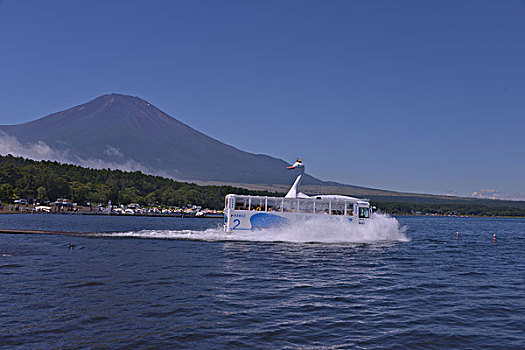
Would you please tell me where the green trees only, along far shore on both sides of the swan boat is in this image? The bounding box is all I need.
[0,155,525,217]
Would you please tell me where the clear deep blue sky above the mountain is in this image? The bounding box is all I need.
[0,0,525,198]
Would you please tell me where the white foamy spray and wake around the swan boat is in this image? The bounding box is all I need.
[101,214,410,243]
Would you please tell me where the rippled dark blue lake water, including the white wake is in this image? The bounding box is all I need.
[0,215,525,349]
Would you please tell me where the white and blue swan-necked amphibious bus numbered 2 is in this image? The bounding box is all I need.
[224,159,372,233]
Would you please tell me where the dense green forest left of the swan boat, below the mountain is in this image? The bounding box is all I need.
[0,155,278,209]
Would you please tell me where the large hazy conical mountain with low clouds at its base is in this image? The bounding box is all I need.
[0,94,323,185]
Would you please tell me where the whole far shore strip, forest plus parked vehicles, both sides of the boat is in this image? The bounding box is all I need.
[0,155,525,217]
